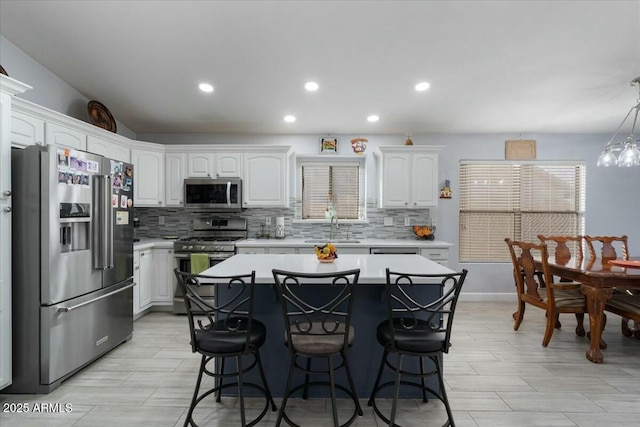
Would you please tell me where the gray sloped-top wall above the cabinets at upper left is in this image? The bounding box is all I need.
[0,36,136,139]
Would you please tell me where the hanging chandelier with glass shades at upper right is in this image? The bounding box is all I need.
[597,77,640,167]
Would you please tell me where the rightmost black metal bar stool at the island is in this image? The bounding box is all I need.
[368,268,467,426]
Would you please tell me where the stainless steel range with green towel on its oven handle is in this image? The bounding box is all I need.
[173,218,247,314]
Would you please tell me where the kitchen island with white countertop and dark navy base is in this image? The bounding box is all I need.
[202,254,454,398]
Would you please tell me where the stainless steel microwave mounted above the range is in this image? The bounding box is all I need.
[184,178,242,212]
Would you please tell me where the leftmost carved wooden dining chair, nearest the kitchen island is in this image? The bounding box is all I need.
[505,238,587,347]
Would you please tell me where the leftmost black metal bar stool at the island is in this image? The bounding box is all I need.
[174,269,276,427]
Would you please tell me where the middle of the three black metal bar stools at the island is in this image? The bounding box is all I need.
[273,269,362,427]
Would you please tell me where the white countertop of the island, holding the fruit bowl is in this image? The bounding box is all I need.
[201,254,455,284]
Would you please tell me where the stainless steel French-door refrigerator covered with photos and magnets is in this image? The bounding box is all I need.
[3,146,135,393]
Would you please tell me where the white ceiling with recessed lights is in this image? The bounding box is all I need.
[0,0,640,134]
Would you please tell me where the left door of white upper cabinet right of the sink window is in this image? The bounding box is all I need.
[382,153,411,208]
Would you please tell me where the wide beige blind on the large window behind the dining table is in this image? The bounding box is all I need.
[460,162,586,262]
